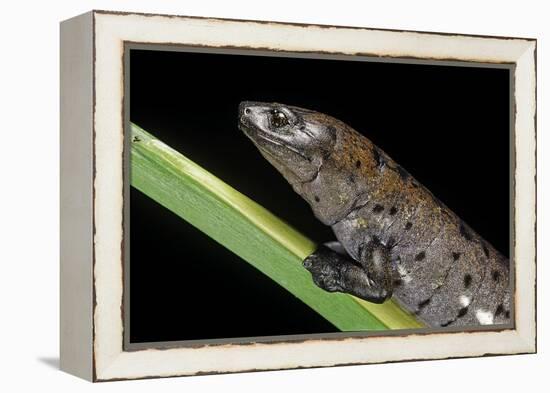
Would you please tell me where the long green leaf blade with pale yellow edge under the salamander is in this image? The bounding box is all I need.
[130,124,422,331]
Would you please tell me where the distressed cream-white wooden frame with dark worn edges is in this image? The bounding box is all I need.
[60,11,536,381]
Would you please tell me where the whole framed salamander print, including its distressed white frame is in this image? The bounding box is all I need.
[61,11,536,381]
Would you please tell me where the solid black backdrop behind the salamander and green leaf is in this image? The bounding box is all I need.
[130,49,510,343]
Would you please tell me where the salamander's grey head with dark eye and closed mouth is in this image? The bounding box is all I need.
[239,101,336,188]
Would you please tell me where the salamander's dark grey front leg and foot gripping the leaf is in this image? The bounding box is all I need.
[303,244,393,303]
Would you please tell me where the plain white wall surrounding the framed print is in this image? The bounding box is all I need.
[0,0,550,393]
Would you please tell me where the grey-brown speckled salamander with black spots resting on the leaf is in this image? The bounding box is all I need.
[238,101,511,327]
